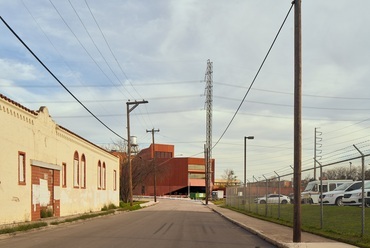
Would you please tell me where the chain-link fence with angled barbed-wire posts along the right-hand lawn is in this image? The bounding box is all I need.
[226,144,370,236]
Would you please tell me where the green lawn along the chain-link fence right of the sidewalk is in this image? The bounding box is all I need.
[219,204,370,248]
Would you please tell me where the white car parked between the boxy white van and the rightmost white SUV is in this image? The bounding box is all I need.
[319,181,362,206]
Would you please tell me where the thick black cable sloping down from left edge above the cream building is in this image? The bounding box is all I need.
[0,16,126,141]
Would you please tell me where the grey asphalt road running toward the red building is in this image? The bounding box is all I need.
[0,199,274,248]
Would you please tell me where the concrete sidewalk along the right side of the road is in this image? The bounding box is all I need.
[208,203,356,248]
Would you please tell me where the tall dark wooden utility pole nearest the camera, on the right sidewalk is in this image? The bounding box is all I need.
[293,0,302,243]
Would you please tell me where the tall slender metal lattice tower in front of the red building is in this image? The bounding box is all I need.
[205,60,213,203]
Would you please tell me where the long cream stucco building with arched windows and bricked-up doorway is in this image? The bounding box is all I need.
[0,94,119,224]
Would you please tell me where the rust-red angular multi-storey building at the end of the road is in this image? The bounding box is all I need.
[133,144,215,196]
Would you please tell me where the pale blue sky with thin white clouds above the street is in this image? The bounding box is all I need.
[0,0,370,181]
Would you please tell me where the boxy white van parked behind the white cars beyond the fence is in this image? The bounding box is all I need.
[301,180,353,204]
